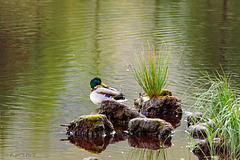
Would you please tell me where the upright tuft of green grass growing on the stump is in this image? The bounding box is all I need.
[131,43,170,99]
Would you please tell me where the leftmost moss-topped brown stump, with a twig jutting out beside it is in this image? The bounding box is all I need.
[64,114,114,137]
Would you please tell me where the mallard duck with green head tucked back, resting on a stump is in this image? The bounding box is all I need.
[90,77,126,105]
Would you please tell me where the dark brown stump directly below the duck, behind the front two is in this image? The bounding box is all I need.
[99,100,145,125]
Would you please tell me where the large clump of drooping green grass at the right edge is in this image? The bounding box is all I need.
[189,71,240,159]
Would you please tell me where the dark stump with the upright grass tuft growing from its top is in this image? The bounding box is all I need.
[134,90,182,128]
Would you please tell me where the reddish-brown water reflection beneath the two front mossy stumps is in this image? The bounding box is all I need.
[61,126,172,153]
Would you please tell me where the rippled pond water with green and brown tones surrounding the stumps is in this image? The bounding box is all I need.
[0,0,240,160]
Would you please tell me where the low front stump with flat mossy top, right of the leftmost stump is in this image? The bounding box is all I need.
[128,118,173,140]
